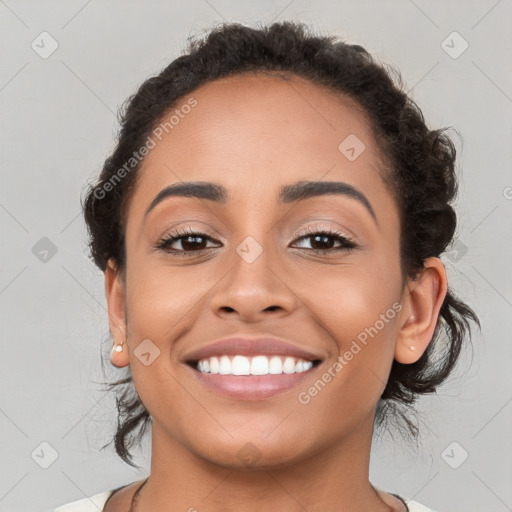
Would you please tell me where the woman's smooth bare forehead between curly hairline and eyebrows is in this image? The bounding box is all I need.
[129,73,392,218]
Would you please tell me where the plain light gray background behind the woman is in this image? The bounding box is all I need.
[0,0,512,512]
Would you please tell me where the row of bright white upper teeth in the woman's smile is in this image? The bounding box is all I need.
[197,355,313,375]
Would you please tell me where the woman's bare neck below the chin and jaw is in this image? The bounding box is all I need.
[136,414,392,512]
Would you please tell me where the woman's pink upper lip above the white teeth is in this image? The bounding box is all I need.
[184,337,321,363]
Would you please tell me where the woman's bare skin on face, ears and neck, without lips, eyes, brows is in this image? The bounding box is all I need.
[105,74,447,512]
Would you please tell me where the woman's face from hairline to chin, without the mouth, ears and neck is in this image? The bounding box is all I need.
[109,75,412,466]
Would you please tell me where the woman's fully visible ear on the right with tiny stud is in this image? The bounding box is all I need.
[395,257,448,364]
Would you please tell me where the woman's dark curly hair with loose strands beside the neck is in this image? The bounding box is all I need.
[82,21,480,466]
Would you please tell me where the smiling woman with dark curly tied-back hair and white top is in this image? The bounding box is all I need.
[53,22,479,512]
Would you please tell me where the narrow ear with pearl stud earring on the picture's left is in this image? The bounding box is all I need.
[105,259,129,368]
